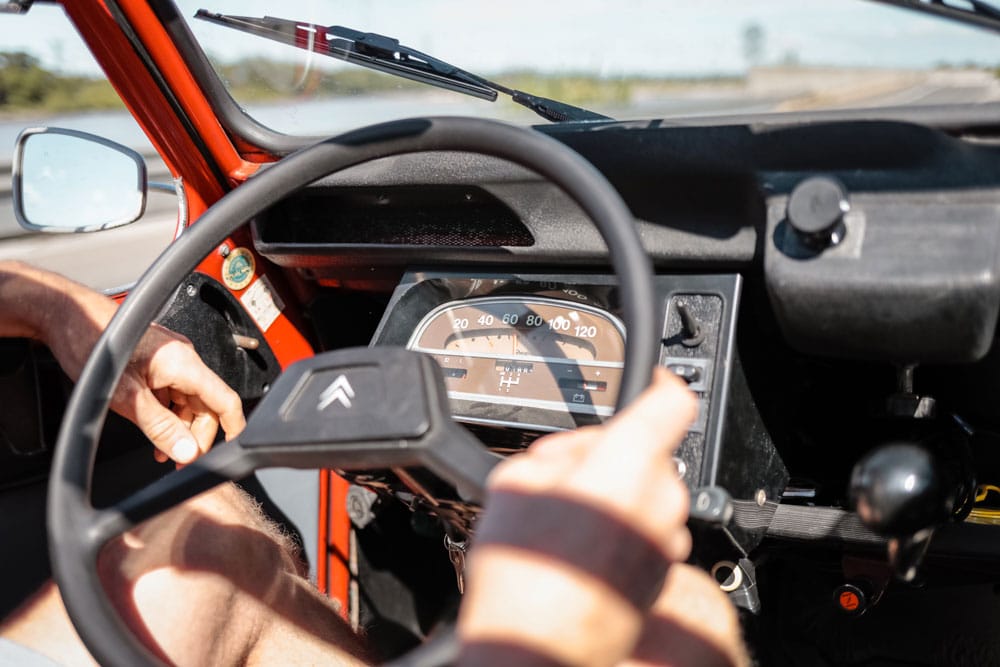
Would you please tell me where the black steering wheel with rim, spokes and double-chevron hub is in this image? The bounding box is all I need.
[47,118,659,667]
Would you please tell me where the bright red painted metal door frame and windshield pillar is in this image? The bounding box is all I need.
[63,0,350,615]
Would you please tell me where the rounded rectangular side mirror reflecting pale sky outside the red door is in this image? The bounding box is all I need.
[11,127,147,232]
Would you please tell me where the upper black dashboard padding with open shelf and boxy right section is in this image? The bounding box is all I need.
[254,121,1000,362]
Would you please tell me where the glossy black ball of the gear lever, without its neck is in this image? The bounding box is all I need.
[850,444,955,536]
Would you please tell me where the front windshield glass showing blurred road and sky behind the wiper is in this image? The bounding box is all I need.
[178,0,1000,134]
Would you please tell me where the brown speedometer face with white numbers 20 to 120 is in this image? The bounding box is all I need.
[407,297,625,427]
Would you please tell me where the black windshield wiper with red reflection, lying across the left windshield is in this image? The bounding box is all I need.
[195,9,612,123]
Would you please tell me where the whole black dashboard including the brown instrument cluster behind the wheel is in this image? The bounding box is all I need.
[244,117,1000,564]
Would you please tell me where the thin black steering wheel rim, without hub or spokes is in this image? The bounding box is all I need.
[47,118,659,666]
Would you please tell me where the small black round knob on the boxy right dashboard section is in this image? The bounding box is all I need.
[787,176,851,252]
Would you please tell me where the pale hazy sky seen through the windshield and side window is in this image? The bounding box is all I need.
[0,0,1000,76]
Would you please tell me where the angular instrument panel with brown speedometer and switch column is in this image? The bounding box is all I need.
[372,271,787,550]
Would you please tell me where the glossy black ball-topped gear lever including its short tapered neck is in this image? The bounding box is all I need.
[850,443,965,581]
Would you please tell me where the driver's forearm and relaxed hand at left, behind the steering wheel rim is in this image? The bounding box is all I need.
[7,263,246,463]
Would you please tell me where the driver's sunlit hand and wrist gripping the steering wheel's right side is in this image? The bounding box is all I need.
[459,370,697,666]
